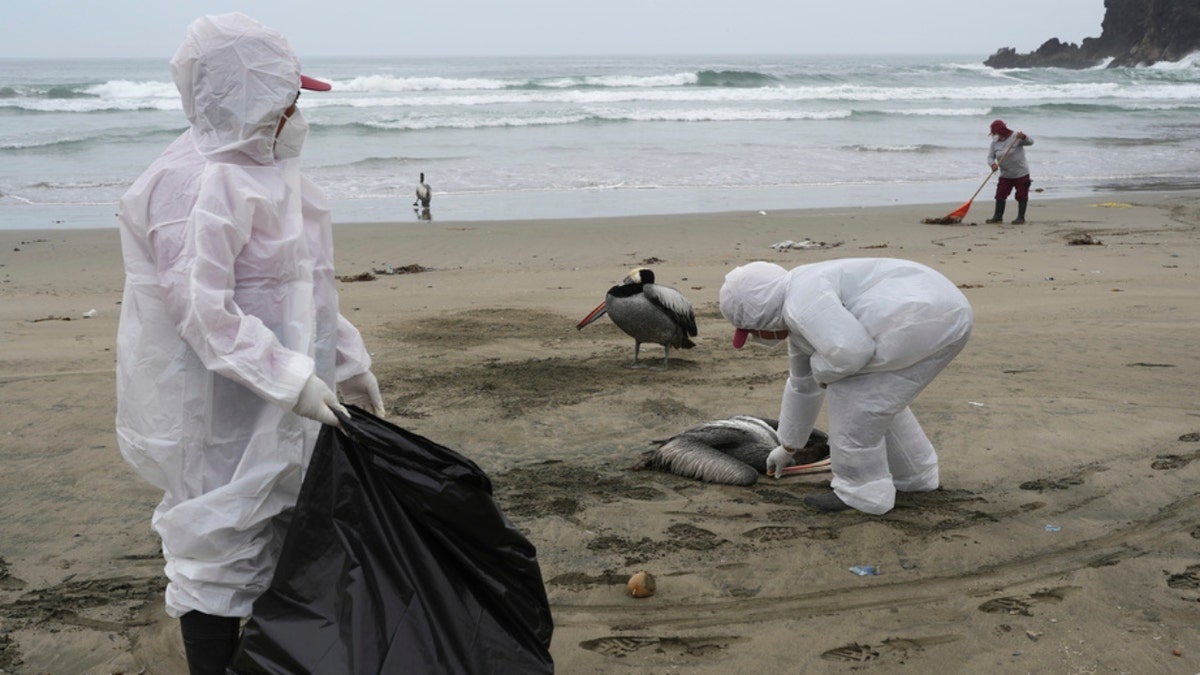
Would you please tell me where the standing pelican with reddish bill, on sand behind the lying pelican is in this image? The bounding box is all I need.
[575,268,696,370]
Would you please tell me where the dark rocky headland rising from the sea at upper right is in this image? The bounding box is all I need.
[984,0,1200,68]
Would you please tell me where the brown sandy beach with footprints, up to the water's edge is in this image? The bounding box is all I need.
[0,192,1200,675]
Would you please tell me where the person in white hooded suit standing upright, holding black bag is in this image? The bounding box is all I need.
[116,14,384,674]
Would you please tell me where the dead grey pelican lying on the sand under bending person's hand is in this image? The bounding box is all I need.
[635,414,829,485]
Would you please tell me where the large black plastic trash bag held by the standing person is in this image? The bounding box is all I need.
[230,407,554,675]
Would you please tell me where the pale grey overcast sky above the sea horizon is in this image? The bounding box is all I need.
[0,0,1104,60]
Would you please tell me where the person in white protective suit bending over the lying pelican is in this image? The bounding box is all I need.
[720,258,972,514]
